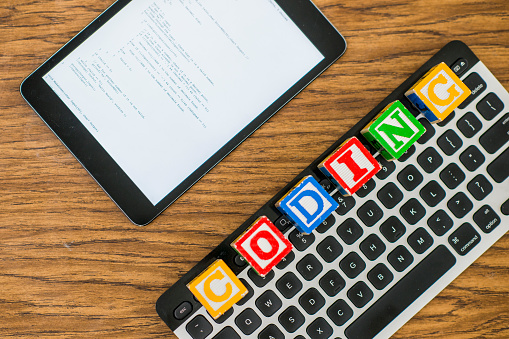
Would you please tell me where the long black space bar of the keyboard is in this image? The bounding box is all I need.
[345,245,456,339]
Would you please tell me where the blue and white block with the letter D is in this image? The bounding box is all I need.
[276,176,339,234]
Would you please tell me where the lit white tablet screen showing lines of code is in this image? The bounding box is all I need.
[43,0,324,205]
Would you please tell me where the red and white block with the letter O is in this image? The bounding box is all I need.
[232,216,293,277]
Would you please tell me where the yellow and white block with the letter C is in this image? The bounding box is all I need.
[187,259,248,319]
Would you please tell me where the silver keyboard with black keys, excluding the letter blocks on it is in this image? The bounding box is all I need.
[156,41,509,339]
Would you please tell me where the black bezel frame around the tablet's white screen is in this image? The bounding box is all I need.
[20,0,346,225]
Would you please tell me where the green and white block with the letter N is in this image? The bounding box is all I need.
[361,100,426,160]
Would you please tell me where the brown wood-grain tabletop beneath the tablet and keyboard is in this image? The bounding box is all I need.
[0,0,509,338]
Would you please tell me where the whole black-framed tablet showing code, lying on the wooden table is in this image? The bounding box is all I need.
[21,0,346,225]
